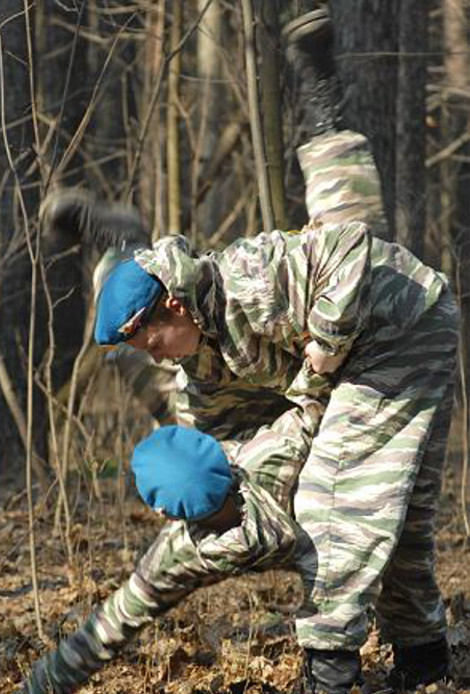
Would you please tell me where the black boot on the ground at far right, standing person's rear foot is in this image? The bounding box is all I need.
[387,637,450,692]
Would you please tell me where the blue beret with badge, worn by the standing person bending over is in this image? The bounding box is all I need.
[95,258,164,345]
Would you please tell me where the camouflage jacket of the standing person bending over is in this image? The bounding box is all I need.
[135,228,446,445]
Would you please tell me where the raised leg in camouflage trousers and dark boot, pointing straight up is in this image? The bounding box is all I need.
[283,2,387,237]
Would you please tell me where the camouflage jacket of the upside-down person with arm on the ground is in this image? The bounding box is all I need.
[22,468,316,694]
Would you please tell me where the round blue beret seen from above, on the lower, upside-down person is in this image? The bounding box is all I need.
[131,426,232,520]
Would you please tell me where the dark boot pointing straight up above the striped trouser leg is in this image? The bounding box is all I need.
[282,5,343,139]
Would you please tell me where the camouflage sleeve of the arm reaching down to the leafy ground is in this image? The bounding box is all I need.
[24,521,214,694]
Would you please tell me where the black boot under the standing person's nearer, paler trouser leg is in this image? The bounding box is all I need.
[305,648,361,694]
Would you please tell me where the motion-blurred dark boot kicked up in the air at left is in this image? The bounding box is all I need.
[39,188,150,250]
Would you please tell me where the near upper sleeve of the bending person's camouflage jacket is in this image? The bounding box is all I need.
[307,222,371,356]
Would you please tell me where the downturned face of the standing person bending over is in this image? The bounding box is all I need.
[127,297,201,362]
